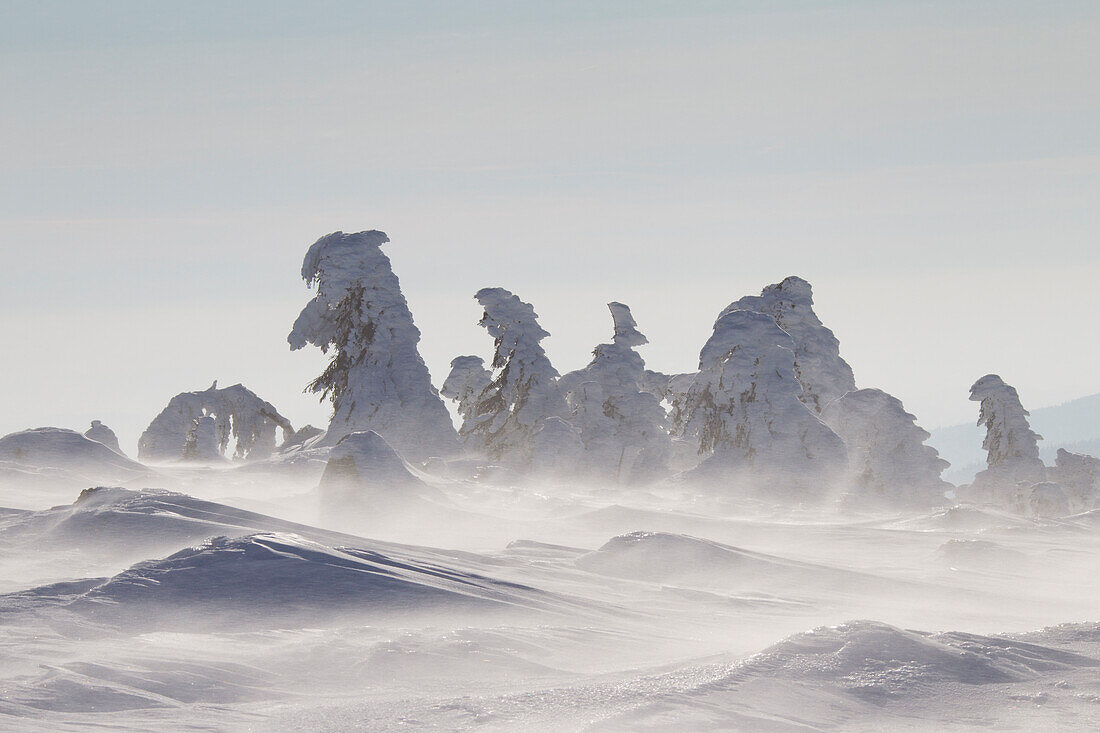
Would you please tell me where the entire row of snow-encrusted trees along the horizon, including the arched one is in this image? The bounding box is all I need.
[126,231,1100,513]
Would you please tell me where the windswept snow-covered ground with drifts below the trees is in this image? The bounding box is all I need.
[0,460,1100,731]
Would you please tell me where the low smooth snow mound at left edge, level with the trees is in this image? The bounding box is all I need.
[0,427,149,483]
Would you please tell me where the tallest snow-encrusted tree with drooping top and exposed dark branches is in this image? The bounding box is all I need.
[287,231,458,460]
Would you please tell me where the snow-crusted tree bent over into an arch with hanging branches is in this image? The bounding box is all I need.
[138,381,294,461]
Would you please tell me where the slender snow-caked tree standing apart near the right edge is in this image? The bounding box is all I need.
[963,374,1046,506]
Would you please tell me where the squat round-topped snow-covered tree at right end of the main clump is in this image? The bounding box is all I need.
[822,390,953,507]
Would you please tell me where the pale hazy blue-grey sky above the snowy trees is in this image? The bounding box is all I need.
[0,0,1100,450]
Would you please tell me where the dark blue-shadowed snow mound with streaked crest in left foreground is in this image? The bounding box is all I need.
[51,533,547,628]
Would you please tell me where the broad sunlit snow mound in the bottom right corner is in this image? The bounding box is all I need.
[601,621,1100,731]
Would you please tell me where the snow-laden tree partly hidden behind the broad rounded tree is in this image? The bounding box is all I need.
[719,275,856,414]
